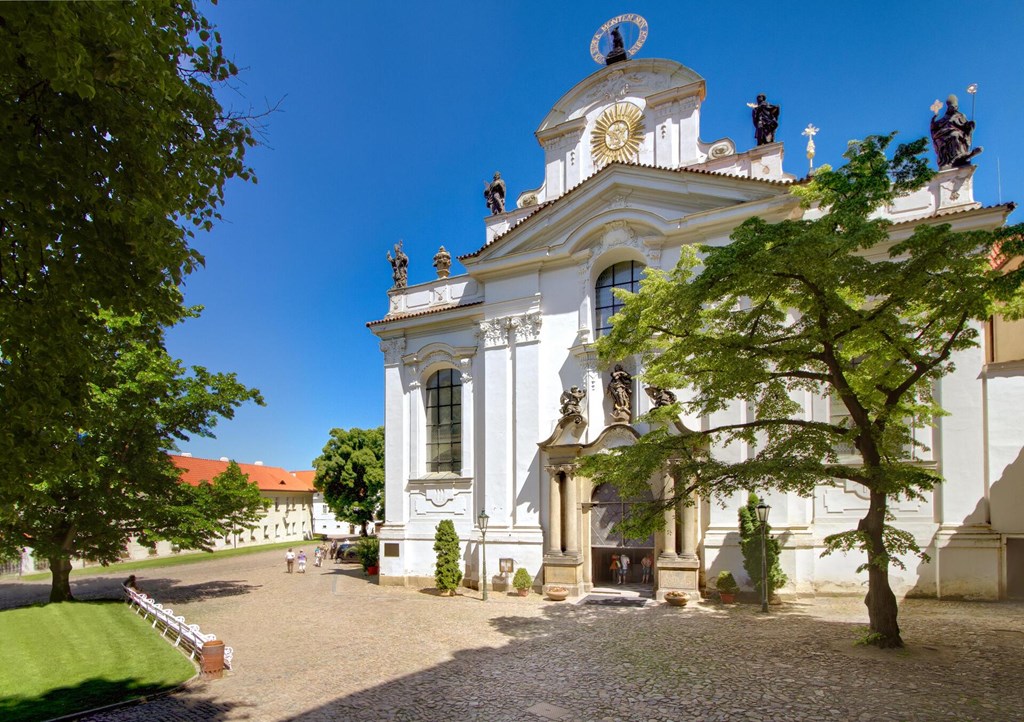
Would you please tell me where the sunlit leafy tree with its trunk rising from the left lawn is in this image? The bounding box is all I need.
[0,314,264,601]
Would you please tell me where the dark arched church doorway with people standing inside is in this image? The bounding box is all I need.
[590,483,654,587]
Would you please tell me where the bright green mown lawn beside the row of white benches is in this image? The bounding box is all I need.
[0,602,196,722]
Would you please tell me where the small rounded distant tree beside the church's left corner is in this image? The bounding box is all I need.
[313,426,384,537]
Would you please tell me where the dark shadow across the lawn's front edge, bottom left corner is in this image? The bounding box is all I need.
[0,679,249,722]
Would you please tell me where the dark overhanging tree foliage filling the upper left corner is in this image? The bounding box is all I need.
[0,0,258,507]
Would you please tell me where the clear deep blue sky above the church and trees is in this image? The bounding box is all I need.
[168,0,1024,470]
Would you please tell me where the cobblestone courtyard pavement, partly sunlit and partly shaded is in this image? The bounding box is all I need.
[0,551,1024,722]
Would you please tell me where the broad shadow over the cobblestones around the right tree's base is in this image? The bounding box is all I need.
[270,604,1020,722]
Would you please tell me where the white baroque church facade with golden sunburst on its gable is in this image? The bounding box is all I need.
[368,50,1024,599]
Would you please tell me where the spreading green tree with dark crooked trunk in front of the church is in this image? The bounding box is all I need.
[585,135,1024,647]
